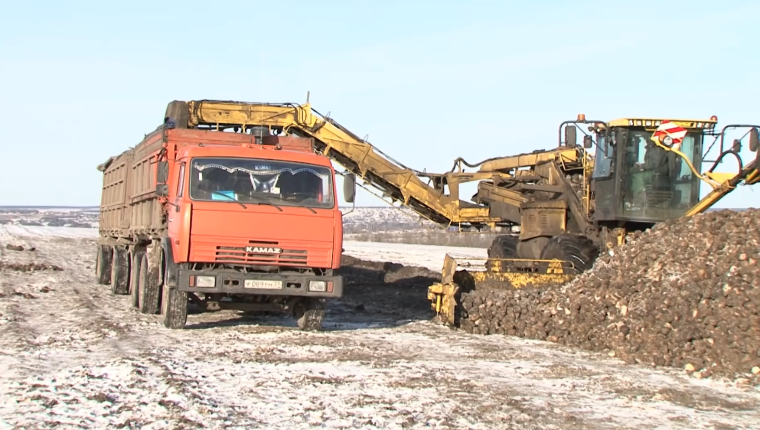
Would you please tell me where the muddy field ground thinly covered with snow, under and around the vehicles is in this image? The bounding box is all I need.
[0,226,760,429]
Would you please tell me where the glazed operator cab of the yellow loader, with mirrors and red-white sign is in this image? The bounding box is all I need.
[563,116,758,228]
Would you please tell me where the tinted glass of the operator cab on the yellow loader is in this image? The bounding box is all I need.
[621,129,702,221]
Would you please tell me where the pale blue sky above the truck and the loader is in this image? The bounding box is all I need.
[0,0,760,207]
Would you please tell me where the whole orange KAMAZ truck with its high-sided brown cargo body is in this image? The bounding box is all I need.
[96,102,356,330]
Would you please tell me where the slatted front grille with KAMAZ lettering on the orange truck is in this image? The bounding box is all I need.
[215,240,308,266]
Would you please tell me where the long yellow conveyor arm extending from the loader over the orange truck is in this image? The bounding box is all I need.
[180,100,499,225]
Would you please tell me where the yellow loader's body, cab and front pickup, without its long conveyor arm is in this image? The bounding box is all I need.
[428,115,760,325]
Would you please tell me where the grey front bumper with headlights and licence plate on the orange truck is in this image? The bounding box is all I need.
[177,269,343,297]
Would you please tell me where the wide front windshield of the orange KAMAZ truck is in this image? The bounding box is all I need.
[190,157,334,208]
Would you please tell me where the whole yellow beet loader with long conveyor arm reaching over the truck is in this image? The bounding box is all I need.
[157,100,760,325]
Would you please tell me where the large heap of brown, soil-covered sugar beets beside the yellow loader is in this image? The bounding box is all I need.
[460,209,760,384]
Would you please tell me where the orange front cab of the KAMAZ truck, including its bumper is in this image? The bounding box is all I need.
[164,132,350,329]
